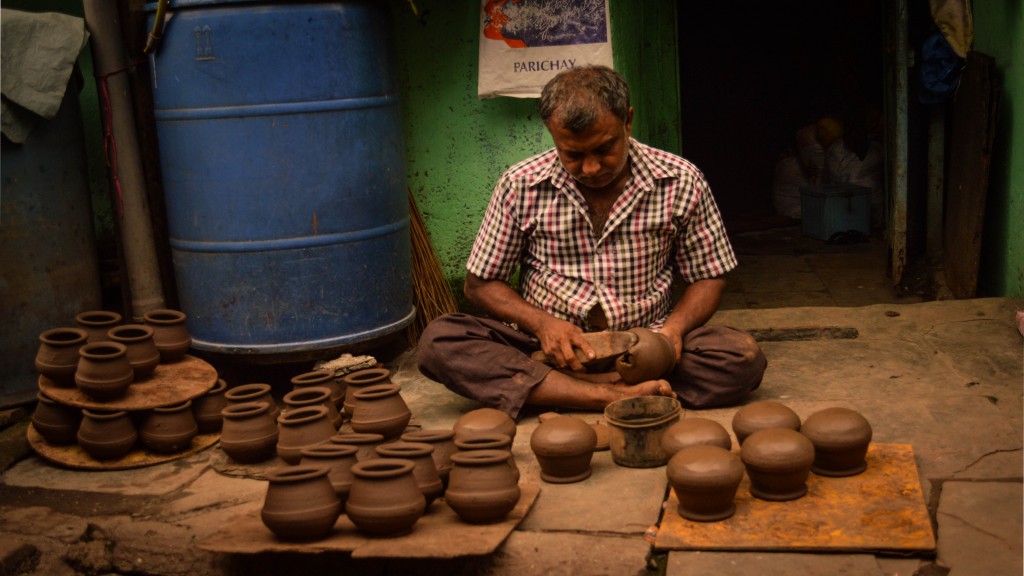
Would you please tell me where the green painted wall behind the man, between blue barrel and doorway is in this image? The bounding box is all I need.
[390,0,679,294]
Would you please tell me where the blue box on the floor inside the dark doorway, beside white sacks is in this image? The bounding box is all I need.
[800,183,871,240]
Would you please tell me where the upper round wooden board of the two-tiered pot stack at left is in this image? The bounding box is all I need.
[39,355,217,411]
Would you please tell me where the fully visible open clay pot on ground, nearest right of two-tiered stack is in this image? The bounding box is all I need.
[220,402,279,463]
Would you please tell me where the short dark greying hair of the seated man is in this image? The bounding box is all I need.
[541,66,630,132]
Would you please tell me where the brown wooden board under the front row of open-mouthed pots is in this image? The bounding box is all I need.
[198,484,541,559]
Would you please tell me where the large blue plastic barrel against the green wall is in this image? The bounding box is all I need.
[147,0,415,355]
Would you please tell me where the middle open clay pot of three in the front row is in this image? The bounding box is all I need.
[345,458,427,536]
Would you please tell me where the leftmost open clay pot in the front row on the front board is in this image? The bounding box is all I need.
[260,466,341,541]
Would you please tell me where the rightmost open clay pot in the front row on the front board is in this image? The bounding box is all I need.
[444,450,520,524]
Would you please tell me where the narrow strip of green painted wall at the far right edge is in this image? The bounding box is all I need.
[974,0,1024,297]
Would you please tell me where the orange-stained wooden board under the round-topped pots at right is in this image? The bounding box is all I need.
[654,444,935,553]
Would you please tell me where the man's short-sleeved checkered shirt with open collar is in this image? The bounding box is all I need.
[466,138,736,330]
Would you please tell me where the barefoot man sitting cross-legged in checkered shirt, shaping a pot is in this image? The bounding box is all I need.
[418,67,767,418]
